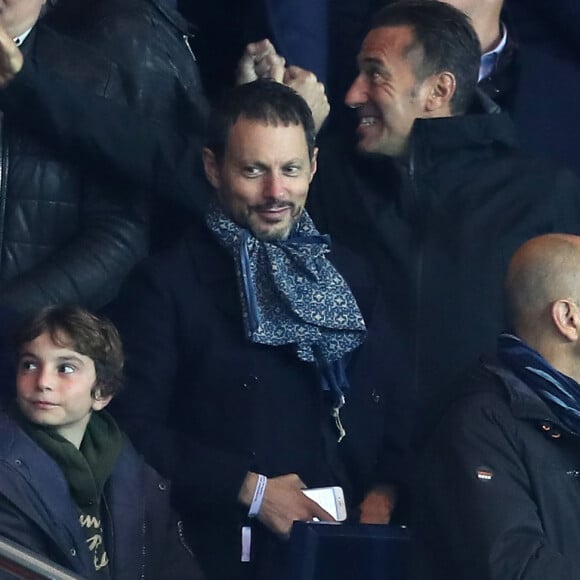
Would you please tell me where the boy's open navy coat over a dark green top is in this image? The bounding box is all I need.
[0,414,202,580]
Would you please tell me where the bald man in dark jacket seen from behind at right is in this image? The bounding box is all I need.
[414,234,580,580]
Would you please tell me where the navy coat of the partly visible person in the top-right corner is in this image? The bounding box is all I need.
[480,0,580,175]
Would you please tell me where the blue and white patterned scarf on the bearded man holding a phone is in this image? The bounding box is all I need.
[206,204,366,407]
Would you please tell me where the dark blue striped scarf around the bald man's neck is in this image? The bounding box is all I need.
[498,334,580,435]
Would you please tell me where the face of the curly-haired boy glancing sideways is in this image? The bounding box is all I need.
[16,332,111,447]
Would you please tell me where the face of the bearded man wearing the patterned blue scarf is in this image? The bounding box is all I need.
[204,116,316,240]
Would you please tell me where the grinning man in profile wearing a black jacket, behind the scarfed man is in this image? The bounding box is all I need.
[309,0,580,436]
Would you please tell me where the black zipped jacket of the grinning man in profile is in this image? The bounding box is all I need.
[309,113,580,426]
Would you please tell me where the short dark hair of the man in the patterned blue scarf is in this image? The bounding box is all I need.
[206,79,316,161]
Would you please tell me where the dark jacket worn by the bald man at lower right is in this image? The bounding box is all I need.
[412,359,580,580]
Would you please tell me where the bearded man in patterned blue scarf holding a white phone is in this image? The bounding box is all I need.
[104,81,404,580]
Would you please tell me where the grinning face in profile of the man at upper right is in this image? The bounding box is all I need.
[345,26,431,157]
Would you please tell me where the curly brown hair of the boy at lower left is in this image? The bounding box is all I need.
[14,305,124,397]
